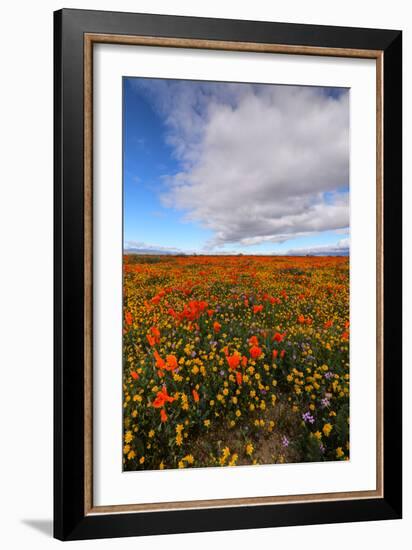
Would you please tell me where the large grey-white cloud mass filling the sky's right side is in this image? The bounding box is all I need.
[131,80,349,250]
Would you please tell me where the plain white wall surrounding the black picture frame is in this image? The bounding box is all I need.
[0,0,412,550]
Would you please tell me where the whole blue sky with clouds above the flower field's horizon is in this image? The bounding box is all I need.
[123,78,349,254]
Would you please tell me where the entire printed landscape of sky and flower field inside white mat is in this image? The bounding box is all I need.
[122,77,350,471]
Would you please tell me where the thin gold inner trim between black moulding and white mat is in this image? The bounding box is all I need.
[84,33,384,515]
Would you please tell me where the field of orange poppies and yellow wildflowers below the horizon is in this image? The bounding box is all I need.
[123,254,349,471]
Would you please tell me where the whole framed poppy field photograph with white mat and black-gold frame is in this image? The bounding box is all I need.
[54,9,402,540]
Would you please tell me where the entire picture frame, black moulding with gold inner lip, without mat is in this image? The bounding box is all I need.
[54,9,402,540]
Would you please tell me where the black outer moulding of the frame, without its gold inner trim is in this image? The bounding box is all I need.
[54,9,402,540]
